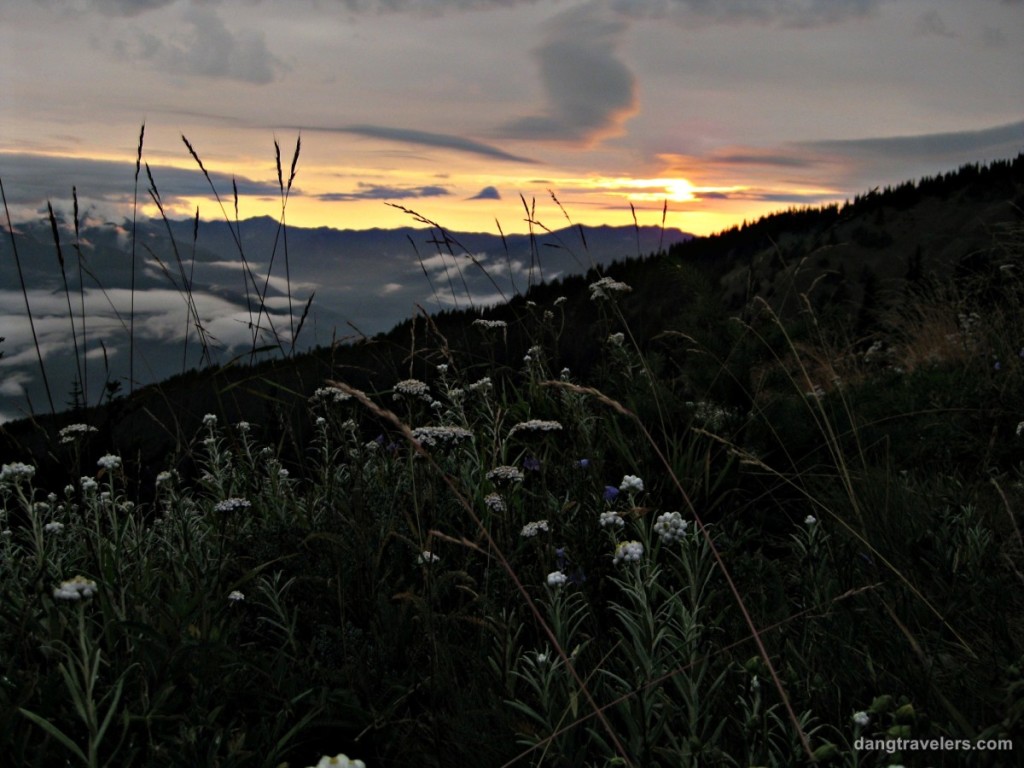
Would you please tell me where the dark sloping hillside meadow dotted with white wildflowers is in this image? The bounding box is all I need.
[0,151,1024,768]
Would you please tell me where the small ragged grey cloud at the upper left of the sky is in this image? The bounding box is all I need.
[131,6,286,85]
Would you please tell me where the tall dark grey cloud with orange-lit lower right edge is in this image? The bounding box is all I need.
[504,5,637,144]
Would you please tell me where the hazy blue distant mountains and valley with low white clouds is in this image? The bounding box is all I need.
[0,217,691,421]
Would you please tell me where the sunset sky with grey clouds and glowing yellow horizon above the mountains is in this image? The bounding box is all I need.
[0,0,1024,234]
